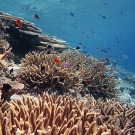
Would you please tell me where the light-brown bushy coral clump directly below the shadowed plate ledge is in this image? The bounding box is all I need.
[19,51,83,92]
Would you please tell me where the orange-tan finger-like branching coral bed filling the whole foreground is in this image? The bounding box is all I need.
[0,93,135,135]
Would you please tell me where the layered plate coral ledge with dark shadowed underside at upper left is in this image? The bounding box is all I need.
[0,12,68,58]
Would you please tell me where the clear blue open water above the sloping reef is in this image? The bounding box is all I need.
[0,0,135,73]
